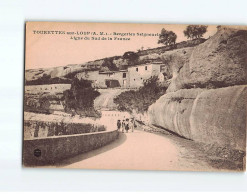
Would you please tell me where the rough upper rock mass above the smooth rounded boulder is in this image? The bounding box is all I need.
[167,28,247,92]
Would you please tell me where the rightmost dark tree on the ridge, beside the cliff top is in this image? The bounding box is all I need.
[184,25,208,39]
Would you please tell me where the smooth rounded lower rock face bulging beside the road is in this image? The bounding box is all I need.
[148,85,247,150]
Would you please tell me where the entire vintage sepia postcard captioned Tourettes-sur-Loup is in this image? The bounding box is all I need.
[22,22,247,171]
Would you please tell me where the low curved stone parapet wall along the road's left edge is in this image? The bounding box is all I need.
[23,130,118,166]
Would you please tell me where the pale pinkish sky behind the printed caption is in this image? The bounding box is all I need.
[25,22,217,69]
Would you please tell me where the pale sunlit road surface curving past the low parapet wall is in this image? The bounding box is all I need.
[60,130,222,171]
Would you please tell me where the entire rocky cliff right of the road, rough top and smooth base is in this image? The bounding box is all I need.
[148,28,247,151]
